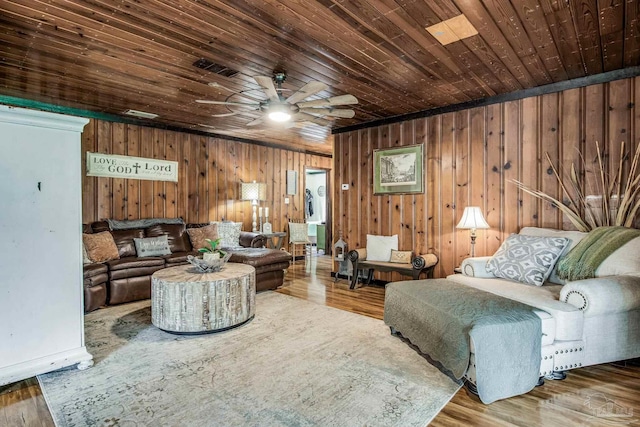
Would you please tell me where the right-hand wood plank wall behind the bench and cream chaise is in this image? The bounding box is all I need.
[333,77,640,280]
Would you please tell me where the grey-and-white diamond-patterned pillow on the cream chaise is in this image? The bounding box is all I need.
[487,234,570,286]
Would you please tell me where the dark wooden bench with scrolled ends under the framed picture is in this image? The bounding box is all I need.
[347,248,438,289]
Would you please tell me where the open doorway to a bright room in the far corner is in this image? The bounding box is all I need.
[304,168,332,255]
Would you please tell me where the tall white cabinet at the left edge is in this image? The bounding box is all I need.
[0,105,93,385]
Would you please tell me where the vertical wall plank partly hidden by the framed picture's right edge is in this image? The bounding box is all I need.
[412,119,430,255]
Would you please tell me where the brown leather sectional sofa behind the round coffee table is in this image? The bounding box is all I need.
[83,221,291,312]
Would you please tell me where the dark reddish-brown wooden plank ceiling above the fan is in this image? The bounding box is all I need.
[0,0,640,153]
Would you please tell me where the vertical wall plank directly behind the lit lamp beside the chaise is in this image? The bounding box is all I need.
[468,107,487,256]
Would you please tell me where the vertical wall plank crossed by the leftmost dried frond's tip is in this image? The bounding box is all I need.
[502,101,522,237]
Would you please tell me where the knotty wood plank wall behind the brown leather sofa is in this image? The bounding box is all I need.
[82,120,332,231]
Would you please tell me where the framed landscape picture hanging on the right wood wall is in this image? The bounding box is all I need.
[373,144,424,195]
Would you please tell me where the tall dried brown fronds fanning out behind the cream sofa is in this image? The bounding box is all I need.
[511,141,640,231]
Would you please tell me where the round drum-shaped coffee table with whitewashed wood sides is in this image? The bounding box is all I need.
[151,262,256,334]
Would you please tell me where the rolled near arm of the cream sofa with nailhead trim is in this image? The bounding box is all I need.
[560,276,640,316]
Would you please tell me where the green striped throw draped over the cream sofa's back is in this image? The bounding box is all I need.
[556,227,640,281]
